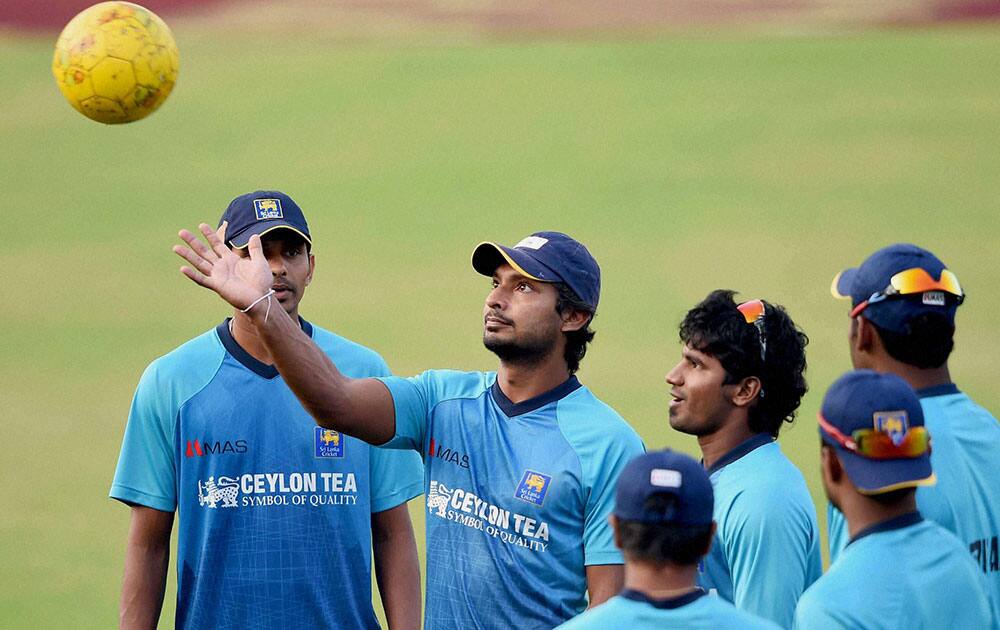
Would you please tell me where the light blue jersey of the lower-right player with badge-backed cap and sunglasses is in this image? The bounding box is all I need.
[795,512,995,630]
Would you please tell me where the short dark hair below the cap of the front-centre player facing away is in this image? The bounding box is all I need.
[618,493,712,565]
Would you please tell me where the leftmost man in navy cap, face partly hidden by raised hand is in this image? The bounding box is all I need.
[111,191,422,629]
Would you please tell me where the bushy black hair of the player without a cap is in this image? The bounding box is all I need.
[680,289,809,437]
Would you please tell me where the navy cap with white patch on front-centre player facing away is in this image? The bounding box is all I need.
[615,449,715,525]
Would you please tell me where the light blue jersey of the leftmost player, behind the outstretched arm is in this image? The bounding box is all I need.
[111,322,422,630]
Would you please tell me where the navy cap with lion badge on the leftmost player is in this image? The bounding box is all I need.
[219,190,312,249]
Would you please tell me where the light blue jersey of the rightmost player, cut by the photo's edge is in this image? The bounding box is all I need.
[827,384,1000,605]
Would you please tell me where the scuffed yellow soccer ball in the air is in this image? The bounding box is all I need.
[52,2,178,124]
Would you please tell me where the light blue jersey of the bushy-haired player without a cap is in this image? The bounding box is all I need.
[699,434,823,628]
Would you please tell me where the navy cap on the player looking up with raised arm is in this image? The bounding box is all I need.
[472,232,601,311]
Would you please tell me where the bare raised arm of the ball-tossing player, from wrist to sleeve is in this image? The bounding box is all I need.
[249,301,395,444]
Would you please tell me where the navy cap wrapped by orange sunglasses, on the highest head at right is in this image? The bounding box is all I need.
[830,243,959,332]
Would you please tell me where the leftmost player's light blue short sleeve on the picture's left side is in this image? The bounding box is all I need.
[110,363,183,512]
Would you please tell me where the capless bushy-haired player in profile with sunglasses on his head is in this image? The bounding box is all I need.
[666,290,822,627]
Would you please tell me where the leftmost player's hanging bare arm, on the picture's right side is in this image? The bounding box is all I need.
[372,503,421,630]
